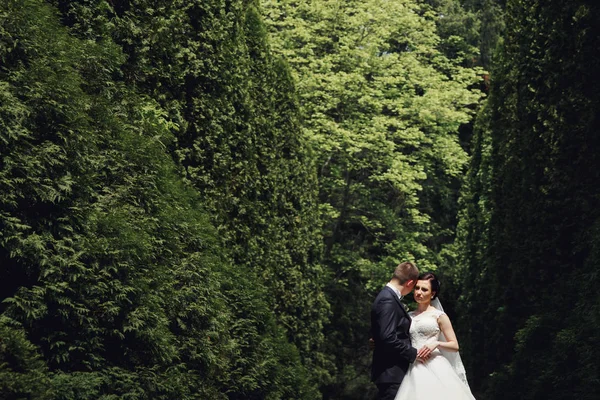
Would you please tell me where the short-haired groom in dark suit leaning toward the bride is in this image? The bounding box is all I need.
[371,262,419,400]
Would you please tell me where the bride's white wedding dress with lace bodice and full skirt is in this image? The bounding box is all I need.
[395,309,475,400]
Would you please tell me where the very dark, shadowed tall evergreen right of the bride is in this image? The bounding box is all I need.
[461,0,600,399]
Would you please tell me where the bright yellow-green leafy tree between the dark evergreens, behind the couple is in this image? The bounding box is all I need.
[262,0,481,398]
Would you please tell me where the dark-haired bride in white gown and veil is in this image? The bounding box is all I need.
[395,272,475,400]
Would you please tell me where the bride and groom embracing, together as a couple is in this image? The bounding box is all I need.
[371,262,474,400]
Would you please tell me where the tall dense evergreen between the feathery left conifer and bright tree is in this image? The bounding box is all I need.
[48,0,328,388]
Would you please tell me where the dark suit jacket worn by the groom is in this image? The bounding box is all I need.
[371,286,417,384]
